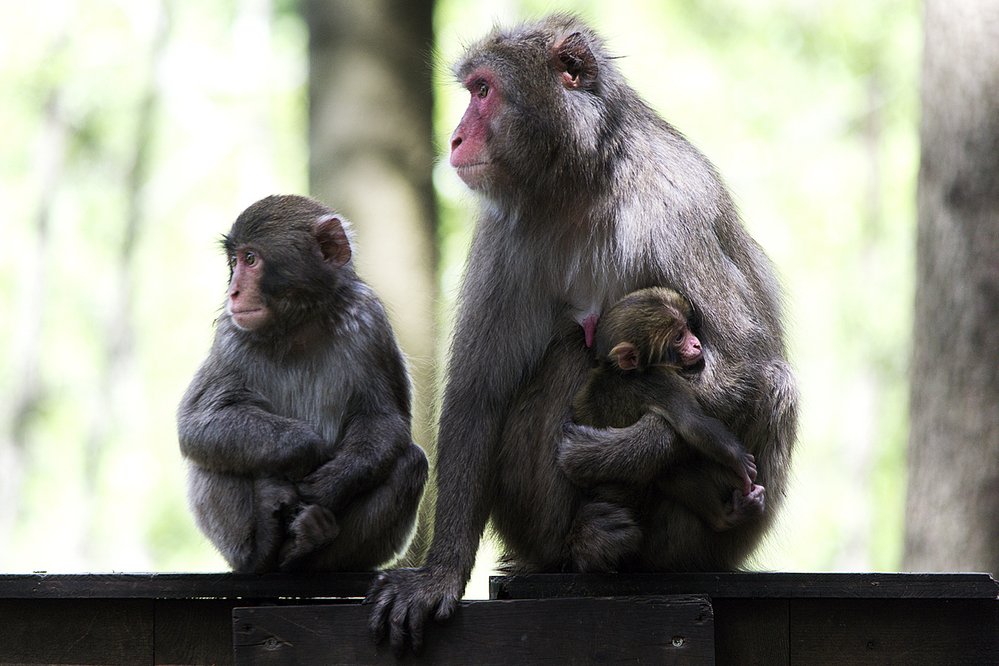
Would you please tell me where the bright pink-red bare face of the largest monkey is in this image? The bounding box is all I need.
[451,69,501,190]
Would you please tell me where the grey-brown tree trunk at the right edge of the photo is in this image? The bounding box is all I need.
[905,0,999,573]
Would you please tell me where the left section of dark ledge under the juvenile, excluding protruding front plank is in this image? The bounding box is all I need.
[0,573,374,665]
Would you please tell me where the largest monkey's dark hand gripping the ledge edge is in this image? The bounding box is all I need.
[364,566,464,657]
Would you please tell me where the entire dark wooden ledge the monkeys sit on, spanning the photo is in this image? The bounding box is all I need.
[0,573,999,664]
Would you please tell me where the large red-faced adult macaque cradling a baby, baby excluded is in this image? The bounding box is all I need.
[368,14,797,651]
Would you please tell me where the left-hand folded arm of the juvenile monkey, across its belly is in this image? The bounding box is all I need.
[177,364,325,478]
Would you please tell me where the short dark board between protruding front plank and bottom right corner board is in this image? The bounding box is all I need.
[711,599,791,666]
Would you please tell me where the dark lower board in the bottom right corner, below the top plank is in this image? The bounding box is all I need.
[790,599,999,666]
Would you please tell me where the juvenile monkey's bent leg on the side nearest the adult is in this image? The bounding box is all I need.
[292,444,428,571]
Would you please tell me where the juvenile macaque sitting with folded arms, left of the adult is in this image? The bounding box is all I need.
[177,196,427,573]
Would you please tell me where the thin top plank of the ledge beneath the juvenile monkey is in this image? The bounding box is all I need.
[0,573,375,599]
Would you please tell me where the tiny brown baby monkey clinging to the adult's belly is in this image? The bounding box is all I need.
[570,287,765,572]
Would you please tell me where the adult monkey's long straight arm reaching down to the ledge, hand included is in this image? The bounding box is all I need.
[367,226,557,652]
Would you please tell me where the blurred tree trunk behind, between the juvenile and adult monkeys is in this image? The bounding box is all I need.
[302,0,437,555]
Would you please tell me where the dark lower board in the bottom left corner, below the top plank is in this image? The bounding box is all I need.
[0,599,154,665]
